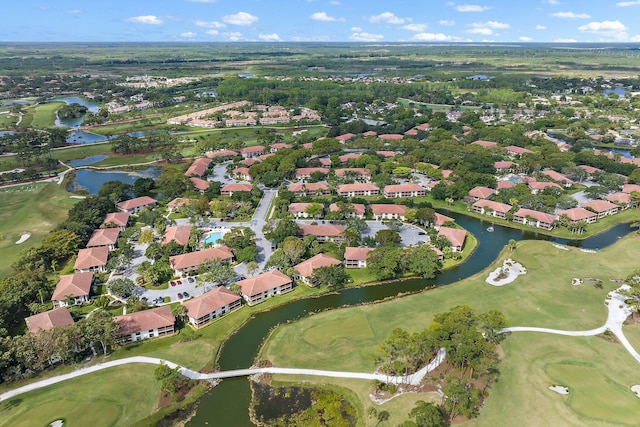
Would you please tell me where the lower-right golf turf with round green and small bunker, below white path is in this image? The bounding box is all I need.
[468,333,640,427]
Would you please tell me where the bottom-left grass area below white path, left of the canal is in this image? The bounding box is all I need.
[0,364,160,427]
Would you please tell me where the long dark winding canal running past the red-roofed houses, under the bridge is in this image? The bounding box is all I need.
[187,211,631,427]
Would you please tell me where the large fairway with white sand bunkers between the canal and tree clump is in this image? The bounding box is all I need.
[260,237,640,372]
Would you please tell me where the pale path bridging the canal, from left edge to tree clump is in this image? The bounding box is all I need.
[0,349,445,402]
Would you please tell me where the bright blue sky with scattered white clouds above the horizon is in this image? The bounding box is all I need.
[0,0,640,43]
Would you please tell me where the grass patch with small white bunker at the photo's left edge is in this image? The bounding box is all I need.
[0,183,78,277]
